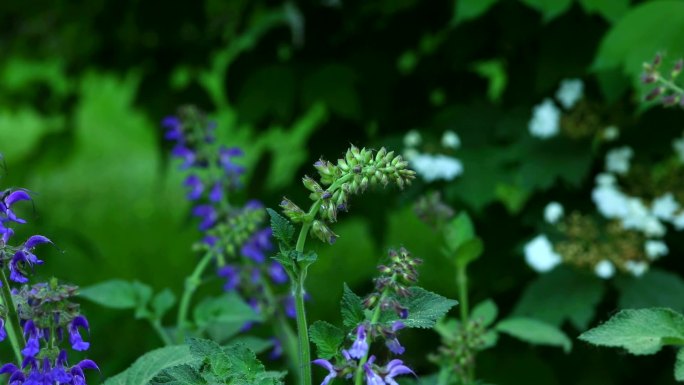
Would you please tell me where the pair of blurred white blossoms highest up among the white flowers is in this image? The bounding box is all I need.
[528,79,584,139]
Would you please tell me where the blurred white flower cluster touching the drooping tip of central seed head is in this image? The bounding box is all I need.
[404,130,463,183]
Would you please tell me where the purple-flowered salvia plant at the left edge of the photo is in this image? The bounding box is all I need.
[0,182,99,385]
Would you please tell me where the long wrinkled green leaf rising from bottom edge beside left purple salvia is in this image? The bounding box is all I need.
[104,345,197,385]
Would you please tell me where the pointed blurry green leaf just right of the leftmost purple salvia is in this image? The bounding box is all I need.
[79,279,152,309]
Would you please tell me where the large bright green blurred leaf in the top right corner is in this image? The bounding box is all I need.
[592,1,684,79]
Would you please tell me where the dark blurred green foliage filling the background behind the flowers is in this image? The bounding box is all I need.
[0,0,684,384]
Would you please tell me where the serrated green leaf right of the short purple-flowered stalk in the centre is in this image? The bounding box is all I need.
[382,287,458,329]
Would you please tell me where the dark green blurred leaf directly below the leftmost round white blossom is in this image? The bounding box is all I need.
[513,267,605,330]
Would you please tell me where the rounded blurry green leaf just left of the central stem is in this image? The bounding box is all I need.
[193,292,262,342]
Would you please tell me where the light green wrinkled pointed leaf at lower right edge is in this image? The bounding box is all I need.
[579,308,684,355]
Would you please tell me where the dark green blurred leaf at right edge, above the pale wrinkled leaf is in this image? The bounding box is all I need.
[615,269,684,311]
